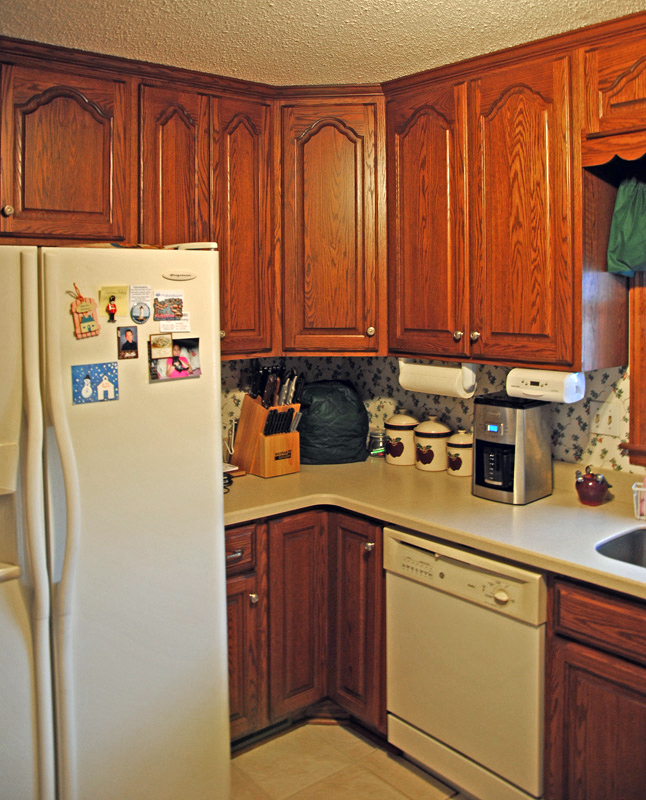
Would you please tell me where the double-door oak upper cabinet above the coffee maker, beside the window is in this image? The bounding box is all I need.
[387,55,627,370]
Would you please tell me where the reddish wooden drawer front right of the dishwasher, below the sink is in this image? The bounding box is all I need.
[553,581,646,664]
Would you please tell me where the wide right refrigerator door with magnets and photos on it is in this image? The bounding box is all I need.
[41,248,229,800]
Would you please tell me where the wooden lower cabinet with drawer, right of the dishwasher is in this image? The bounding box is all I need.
[545,581,646,800]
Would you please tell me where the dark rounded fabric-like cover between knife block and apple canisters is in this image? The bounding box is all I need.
[298,381,369,464]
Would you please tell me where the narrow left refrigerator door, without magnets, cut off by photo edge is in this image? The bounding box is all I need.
[0,247,55,800]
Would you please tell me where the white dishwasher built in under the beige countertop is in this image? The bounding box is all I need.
[384,528,546,800]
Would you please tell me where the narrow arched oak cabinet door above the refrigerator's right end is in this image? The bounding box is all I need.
[139,84,210,245]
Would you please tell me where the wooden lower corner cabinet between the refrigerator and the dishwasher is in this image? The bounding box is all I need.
[226,510,386,740]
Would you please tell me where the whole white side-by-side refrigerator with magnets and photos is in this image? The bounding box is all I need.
[0,246,229,800]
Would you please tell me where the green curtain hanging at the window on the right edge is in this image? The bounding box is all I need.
[608,178,646,276]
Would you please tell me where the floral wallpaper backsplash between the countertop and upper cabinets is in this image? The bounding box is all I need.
[222,356,644,474]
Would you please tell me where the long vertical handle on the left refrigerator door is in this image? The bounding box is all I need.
[20,248,56,800]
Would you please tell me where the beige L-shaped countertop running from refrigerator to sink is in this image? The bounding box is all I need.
[224,459,646,599]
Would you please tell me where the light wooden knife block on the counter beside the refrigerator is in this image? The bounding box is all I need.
[231,394,301,478]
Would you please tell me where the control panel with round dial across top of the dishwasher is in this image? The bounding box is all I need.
[384,528,545,625]
